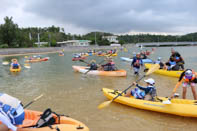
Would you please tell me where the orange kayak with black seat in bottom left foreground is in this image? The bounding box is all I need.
[17,110,89,131]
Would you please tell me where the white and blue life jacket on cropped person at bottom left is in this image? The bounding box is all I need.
[0,94,21,124]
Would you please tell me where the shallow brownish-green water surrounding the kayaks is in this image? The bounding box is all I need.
[0,47,197,131]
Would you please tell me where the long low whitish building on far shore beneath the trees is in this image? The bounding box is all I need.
[57,40,91,46]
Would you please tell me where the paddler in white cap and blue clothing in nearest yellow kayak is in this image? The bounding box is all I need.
[124,78,157,101]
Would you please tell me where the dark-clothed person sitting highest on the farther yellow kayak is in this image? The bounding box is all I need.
[170,48,185,70]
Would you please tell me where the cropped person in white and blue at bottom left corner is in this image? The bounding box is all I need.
[0,93,25,131]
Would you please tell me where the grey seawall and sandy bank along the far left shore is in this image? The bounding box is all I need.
[0,46,123,57]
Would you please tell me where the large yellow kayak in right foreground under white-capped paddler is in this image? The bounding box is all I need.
[102,88,197,117]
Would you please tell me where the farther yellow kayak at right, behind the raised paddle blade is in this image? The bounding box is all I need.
[145,64,183,77]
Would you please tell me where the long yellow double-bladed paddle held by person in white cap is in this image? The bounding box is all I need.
[98,64,160,109]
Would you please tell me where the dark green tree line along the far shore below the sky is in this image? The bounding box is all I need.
[0,16,197,48]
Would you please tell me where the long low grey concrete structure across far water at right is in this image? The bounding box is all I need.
[136,42,197,47]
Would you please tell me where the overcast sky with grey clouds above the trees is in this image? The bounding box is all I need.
[0,0,197,34]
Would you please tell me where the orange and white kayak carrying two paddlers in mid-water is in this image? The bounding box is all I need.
[72,66,127,76]
